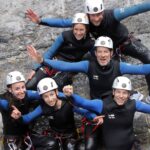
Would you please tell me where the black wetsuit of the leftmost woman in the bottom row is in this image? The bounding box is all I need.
[0,92,29,150]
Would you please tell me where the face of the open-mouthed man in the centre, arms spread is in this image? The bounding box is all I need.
[95,47,113,66]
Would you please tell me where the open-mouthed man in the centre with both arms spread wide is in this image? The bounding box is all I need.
[27,36,150,98]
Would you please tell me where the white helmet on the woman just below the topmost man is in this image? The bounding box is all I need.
[72,13,89,24]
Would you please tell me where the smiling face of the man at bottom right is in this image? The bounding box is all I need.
[113,89,130,106]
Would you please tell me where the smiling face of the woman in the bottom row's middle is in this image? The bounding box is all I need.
[42,90,58,107]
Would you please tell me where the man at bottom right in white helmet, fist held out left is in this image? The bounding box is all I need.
[63,76,150,150]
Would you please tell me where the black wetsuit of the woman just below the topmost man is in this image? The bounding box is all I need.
[26,30,94,91]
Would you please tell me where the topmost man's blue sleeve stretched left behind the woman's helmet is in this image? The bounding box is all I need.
[40,18,72,28]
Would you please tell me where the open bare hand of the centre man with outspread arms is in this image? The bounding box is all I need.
[27,45,43,63]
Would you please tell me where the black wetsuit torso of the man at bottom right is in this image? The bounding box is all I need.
[102,98,136,150]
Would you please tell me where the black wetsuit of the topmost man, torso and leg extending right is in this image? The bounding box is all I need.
[89,9,150,91]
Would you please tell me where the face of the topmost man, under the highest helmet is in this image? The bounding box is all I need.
[88,12,104,26]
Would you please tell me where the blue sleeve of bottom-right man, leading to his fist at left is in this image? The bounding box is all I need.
[72,94,103,113]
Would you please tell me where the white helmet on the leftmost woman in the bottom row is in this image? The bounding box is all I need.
[6,71,25,85]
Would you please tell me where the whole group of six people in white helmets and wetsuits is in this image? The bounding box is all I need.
[0,0,150,150]
